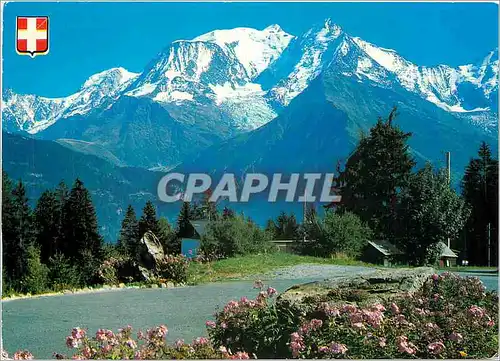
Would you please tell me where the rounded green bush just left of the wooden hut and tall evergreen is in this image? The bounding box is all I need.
[299,211,372,258]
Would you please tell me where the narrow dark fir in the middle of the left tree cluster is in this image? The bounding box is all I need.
[33,190,60,263]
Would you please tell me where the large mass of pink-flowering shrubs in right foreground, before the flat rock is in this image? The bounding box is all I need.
[207,273,498,358]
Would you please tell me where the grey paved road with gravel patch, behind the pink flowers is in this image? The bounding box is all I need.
[3,265,498,359]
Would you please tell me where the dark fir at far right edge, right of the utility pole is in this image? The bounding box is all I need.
[462,142,498,265]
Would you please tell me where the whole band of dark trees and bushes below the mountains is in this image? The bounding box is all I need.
[2,106,498,293]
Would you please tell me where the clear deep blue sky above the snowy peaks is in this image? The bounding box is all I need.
[3,2,498,97]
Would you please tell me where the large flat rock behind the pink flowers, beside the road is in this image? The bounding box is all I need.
[278,267,435,305]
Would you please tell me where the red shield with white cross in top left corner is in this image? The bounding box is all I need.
[16,16,49,57]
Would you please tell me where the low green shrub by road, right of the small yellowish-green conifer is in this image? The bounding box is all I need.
[48,253,80,291]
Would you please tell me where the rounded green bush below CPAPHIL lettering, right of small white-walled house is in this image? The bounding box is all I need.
[201,216,274,257]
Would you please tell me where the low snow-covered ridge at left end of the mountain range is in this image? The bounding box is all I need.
[2,68,138,134]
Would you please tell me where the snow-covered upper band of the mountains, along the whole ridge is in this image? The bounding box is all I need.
[2,19,499,134]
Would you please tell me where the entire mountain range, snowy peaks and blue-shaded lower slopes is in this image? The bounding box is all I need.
[2,19,499,239]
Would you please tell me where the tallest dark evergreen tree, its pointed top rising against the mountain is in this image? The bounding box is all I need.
[337,108,415,238]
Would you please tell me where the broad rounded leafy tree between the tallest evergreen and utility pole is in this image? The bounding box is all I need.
[393,164,469,265]
